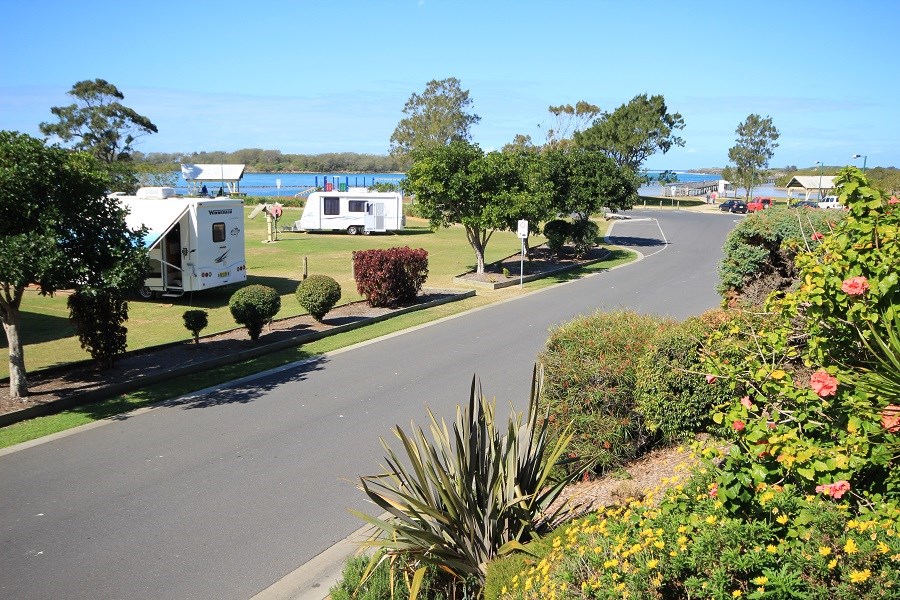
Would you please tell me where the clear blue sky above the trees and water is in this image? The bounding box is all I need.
[0,0,900,169]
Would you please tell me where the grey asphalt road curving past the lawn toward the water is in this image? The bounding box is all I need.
[0,211,736,599]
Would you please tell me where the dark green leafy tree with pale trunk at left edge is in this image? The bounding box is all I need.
[0,131,146,398]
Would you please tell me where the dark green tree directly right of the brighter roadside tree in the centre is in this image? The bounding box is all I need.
[543,148,638,220]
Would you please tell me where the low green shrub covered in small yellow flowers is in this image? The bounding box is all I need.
[486,468,900,600]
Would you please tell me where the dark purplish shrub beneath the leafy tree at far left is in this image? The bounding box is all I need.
[67,289,128,369]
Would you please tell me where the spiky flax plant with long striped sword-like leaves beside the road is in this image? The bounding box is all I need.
[356,368,585,585]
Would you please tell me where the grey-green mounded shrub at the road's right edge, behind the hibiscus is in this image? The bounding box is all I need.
[719,208,844,305]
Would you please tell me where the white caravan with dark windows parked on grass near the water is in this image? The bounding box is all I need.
[285,188,406,234]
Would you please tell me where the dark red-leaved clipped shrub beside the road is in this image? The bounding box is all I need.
[353,246,428,306]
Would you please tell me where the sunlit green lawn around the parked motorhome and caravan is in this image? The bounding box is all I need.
[0,207,620,377]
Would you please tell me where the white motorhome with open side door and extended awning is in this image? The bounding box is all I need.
[118,188,247,298]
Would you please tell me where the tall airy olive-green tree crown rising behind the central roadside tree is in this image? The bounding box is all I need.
[391,77,481,154]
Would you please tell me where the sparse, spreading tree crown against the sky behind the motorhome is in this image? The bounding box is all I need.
[40,79,157,164]
